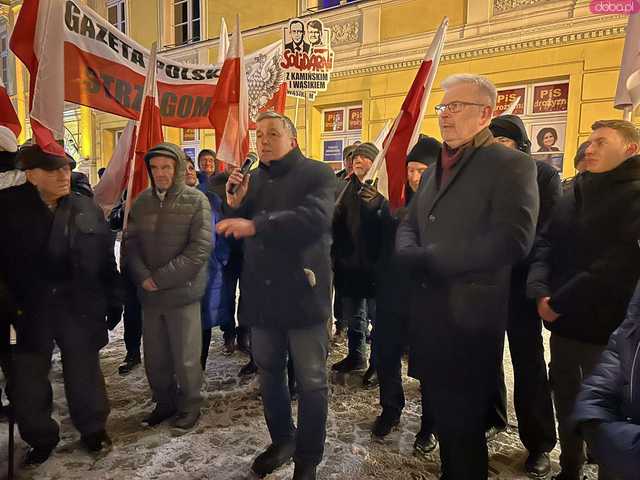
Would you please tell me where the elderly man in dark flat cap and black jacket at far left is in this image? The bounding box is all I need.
[0,145,122,464]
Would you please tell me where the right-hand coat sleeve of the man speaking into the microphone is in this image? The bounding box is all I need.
[253,163,336,249]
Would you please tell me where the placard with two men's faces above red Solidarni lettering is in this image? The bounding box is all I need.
[280,18,334,100]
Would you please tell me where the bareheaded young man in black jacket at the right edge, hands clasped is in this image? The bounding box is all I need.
[527,120,640,480]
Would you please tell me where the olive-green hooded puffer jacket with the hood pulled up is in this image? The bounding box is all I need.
[123,143,212,307]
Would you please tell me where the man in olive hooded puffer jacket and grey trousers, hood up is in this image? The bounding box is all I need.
[123,143,212,429]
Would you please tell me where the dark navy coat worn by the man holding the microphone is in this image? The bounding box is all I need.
[225,147,336,329]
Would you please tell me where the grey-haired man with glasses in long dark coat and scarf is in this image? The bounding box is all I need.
[396,74,539,480]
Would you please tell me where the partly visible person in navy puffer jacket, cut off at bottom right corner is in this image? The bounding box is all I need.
[574,282,640,480]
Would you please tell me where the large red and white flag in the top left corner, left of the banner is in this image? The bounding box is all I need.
[9,0,65,156]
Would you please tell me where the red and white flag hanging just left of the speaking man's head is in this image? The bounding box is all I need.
[209,16,249,167]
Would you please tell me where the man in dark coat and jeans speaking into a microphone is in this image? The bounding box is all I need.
[217,112,336,480]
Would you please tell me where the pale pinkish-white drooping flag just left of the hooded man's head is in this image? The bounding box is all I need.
[93,120,136,214]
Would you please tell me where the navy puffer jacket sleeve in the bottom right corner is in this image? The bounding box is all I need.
[574,328,640,478]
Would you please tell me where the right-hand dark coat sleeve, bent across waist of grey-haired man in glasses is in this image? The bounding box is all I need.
[398,152,539,277]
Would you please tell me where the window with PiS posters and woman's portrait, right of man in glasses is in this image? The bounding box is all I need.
[496,80,569,175]
